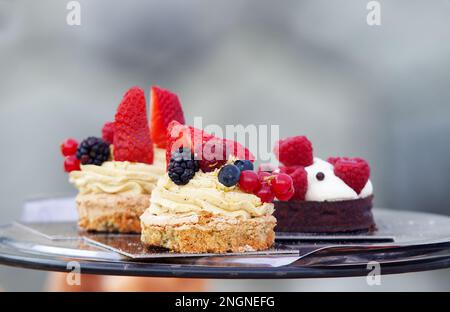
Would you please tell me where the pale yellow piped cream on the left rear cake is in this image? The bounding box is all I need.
[70,148,166,195]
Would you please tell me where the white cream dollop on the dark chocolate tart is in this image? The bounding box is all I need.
[305,158,373,201]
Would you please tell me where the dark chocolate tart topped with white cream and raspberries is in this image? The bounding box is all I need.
[263,136,376,233]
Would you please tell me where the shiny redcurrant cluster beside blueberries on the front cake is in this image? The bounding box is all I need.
[239,170,295,203]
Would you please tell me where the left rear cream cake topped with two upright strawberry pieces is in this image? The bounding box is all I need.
[61,87,184,233]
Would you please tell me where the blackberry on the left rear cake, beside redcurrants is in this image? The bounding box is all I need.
[77,137,110,166]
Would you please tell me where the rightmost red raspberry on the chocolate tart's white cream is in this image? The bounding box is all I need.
[328,157,370,194]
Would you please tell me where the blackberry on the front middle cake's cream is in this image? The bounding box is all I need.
[168,147,200,185]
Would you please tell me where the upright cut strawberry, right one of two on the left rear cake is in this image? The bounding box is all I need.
[151,86,184,148]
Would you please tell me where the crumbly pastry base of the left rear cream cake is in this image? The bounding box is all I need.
[76,194,150,233]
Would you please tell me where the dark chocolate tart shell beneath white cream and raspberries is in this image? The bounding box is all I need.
[274,195,376,233]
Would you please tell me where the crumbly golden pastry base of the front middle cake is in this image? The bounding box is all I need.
[141,215,276,253]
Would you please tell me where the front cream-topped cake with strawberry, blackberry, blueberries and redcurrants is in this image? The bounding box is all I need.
[141,122,282,253]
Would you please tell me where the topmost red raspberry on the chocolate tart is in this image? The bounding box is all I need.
[273,136,313,167]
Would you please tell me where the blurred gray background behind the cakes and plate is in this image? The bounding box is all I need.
[0,0,450,290]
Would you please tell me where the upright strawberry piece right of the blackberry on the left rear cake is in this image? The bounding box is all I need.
[114,87,153,164]
